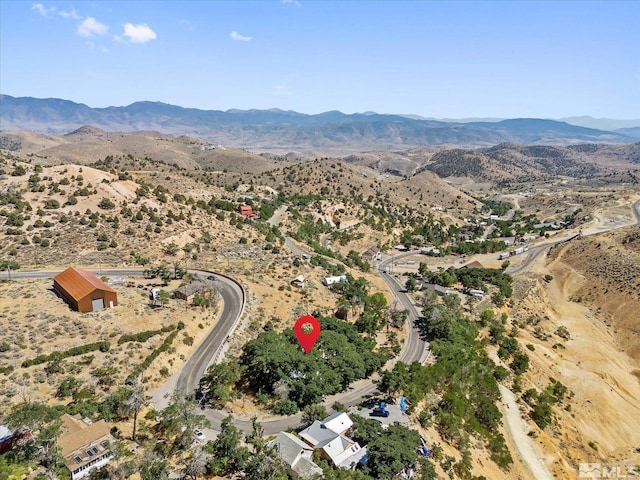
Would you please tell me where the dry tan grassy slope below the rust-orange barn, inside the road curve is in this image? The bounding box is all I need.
[0,278,218,415]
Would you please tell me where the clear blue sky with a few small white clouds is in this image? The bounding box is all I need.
[0,0,640,119]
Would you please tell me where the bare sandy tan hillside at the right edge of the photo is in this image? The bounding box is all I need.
[514,227,640,479]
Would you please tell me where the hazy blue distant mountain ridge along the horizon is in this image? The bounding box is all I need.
[0,95,636,151]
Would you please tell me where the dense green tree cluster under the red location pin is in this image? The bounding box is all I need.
[200,318,387,414]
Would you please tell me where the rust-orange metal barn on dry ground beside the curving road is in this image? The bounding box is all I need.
[53,267,118,313]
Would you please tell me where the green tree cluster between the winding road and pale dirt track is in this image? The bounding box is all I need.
[392,295,512,470]
